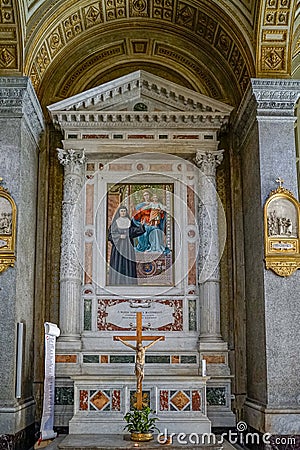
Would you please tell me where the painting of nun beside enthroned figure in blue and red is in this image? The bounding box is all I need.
[106,183,174,286]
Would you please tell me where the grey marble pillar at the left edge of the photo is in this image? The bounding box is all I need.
[0,77,44,442]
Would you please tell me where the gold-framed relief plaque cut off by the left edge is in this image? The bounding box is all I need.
[0,178,17,274]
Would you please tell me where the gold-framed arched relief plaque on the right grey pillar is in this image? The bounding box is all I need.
[264,177,300,277]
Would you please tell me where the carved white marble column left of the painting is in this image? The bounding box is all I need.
[58,149,85,341]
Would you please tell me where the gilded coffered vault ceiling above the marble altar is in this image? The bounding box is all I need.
[0,0,300,111]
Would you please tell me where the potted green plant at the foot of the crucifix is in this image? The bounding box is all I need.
[124,406,159,441]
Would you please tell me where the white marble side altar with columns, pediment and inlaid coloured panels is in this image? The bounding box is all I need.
[49,71,235,434]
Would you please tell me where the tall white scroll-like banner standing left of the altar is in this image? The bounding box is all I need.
[40,322,60,441]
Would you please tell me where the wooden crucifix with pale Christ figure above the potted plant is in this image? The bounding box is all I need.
[114,312,165,409]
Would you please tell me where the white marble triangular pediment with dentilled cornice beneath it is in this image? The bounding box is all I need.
[48,70,233,131]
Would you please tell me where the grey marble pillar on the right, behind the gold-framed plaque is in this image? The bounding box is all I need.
[234,79,300,434]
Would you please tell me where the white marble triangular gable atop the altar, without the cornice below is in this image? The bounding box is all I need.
[48,70,232,115]
